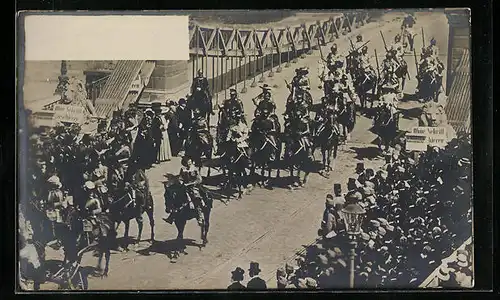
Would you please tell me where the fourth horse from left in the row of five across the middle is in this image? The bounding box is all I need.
[284,120,312,189]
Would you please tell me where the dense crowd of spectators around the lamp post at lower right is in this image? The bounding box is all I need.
[276,135,472,289]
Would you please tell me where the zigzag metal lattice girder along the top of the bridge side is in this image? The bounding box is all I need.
[189,11,368,57]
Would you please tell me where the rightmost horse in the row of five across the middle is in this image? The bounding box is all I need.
[312,111,340,174]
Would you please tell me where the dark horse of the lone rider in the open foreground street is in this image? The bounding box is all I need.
[164,180,213,245]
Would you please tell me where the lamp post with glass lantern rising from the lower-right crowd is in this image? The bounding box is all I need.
[342,203,366,288]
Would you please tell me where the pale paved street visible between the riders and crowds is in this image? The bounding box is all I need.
[44,14,448,290]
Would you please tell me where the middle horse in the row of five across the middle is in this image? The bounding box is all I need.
[249,117,281,186]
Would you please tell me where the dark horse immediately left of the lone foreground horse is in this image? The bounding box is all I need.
[109,163,155,247]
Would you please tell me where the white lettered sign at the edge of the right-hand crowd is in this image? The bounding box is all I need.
[406,127,448,151]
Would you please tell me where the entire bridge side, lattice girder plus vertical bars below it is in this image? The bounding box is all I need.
[190,11,370,103]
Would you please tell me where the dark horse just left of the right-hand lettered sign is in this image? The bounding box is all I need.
[373,105,399,154]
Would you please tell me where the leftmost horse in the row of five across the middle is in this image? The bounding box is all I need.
[184,120,214,177]
